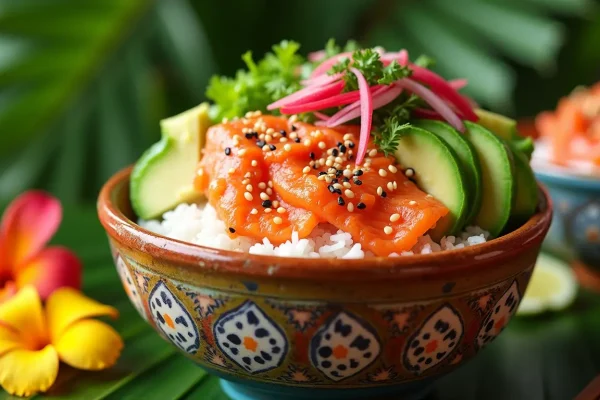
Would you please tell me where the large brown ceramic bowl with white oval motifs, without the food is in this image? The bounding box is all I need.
[98,169,552,399]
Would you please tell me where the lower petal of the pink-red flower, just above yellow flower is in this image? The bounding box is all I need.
[15,247,81,299]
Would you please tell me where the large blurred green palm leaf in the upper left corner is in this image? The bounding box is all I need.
[0,0,215,203]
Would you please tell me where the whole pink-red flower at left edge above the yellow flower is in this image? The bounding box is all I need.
[0,191,81,302]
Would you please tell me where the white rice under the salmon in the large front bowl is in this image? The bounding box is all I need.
[139,204,489,259]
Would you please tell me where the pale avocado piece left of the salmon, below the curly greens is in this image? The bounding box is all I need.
[130,103,210,219]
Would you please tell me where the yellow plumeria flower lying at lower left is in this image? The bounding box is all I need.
[0,286,123,396]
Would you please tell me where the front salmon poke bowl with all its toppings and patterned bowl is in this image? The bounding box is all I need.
[98,41,552,399]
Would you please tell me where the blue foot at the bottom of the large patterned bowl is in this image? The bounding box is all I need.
[221,379,432,400]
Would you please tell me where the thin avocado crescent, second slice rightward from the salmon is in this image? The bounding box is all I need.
[411,119,482,224]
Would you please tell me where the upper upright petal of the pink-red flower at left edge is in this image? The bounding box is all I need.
[0,191,62,271]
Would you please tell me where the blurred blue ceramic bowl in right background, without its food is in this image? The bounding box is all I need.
[534,165,600,286]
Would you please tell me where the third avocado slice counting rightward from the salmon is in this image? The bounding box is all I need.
[465,121,516,237]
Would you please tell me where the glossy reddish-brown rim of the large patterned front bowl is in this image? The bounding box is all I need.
[97,166,553,282]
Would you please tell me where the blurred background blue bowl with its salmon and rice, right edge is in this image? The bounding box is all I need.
[532,83,600,282]
